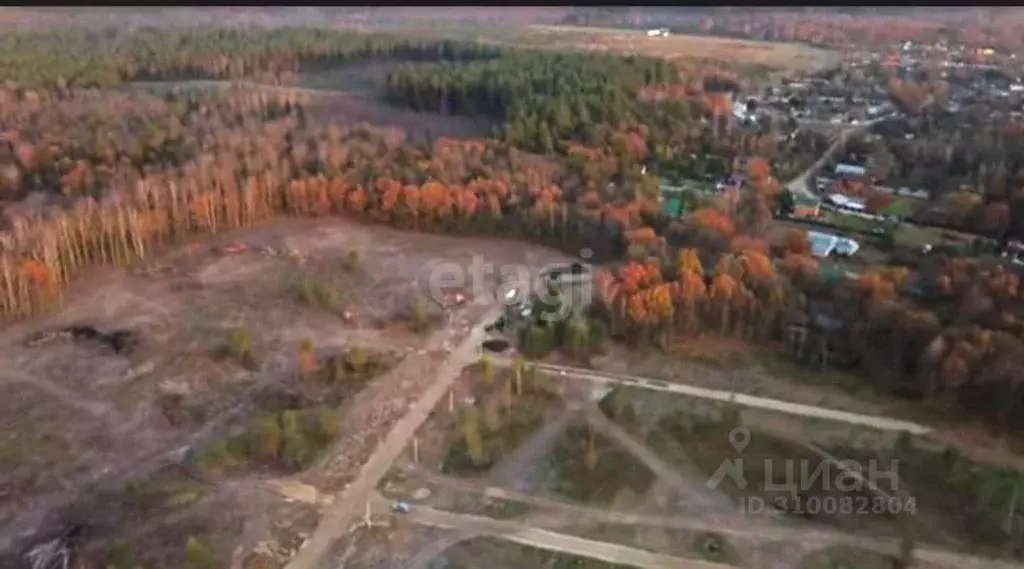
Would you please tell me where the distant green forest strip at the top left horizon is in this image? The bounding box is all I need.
[0,27,502,89]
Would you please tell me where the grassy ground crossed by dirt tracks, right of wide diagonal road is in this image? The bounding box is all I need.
[360,364,1005,569]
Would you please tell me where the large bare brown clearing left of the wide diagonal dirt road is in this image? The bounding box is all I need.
[0,215,565,567]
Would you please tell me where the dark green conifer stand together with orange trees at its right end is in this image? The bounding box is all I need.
[386,51,827,183]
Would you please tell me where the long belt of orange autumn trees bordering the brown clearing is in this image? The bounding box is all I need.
[6,25,1024,435]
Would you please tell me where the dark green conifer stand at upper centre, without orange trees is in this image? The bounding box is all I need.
[386,51,680,154]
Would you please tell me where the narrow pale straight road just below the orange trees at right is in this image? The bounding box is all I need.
[494,358,932,435]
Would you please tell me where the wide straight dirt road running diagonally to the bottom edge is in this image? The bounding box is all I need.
[286,305,504,569]
